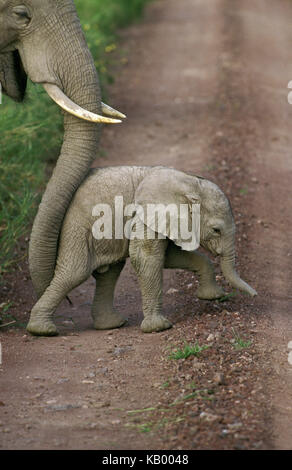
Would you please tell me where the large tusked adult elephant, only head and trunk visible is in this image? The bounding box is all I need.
[0,0,124,297]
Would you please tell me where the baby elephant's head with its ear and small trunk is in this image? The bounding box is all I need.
[135,167,257,296]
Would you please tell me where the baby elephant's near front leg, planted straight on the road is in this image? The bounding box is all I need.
[129,240,172,333]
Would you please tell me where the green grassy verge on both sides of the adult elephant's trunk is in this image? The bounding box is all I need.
[0,0,149,282]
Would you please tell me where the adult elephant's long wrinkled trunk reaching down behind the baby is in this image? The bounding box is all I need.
[28,2,101,297]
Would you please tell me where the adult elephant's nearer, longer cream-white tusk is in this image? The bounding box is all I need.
[43,83,122,124]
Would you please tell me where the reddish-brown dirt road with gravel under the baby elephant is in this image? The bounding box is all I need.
[0,0,292,449]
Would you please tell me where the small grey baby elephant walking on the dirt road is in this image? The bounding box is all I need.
[27,167,256,336]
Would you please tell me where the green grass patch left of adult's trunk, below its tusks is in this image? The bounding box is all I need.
[0,84,62,277]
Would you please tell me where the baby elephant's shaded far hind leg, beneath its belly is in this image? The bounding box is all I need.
[91,261,126,330]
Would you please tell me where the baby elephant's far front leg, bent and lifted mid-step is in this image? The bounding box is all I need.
[164,243,224,300]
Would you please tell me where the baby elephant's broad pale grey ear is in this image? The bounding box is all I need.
[135,167,200,251]
